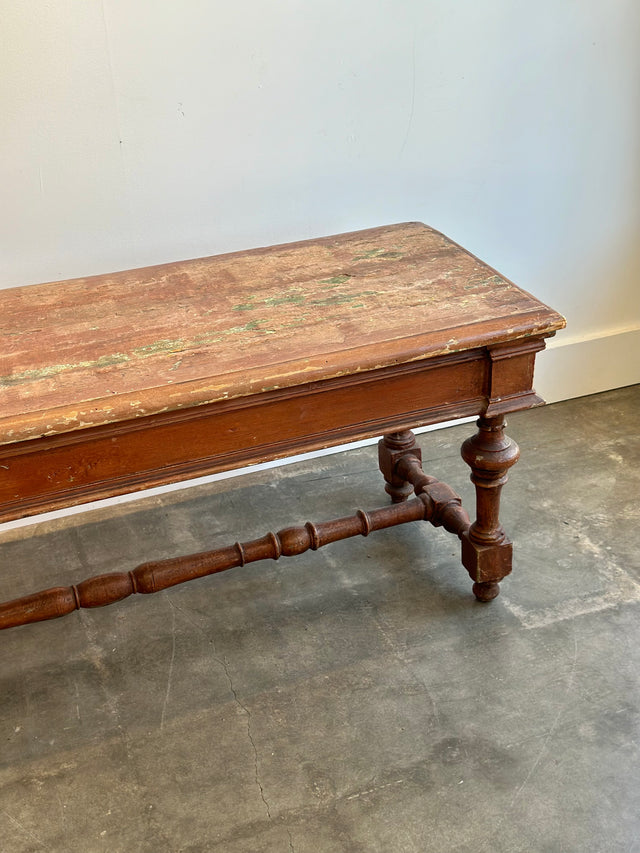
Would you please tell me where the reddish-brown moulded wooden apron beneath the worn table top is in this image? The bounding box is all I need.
[0,341,544,521]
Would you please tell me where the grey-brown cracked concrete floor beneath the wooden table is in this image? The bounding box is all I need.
[0,386,640,853]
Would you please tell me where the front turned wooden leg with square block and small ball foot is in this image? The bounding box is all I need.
[462,415,520,601]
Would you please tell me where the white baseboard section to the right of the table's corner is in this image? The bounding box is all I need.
[535,329,640,403]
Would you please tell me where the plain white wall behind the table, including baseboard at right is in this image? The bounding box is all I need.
[0,0,640,399]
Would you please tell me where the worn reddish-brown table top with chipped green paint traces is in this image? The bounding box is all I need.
[0,222,565,444]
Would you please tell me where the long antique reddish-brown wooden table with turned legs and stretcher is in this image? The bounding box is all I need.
[0,223,564,627]
